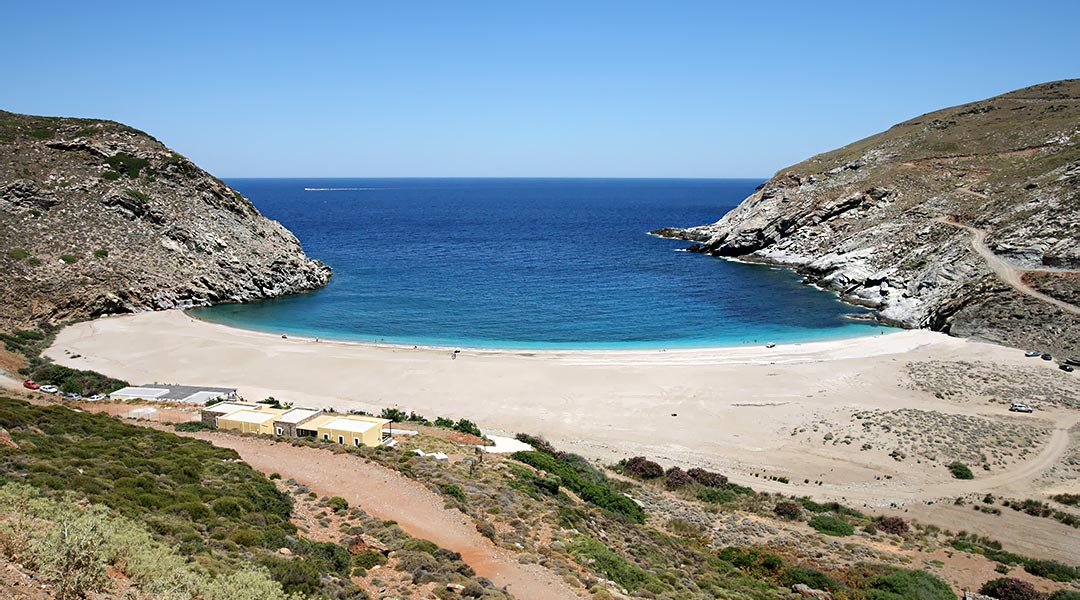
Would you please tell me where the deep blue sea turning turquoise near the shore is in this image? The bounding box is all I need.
[195,179,879,349]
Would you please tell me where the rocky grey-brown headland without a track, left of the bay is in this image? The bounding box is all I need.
[0,111,330,328]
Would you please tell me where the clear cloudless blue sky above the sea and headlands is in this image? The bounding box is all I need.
[0,0,1080,177]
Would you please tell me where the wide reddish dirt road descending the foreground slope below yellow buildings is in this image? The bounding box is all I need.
[179,433,581,600]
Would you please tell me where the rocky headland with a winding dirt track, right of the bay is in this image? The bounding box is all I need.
[654,80,1080,354]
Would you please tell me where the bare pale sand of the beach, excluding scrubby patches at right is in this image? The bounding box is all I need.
[46,311,1076,504]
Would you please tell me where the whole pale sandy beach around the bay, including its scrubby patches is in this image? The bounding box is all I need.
[48,311,1080,506]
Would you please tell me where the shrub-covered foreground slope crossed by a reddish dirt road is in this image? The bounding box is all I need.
[8,394,1080,600]
